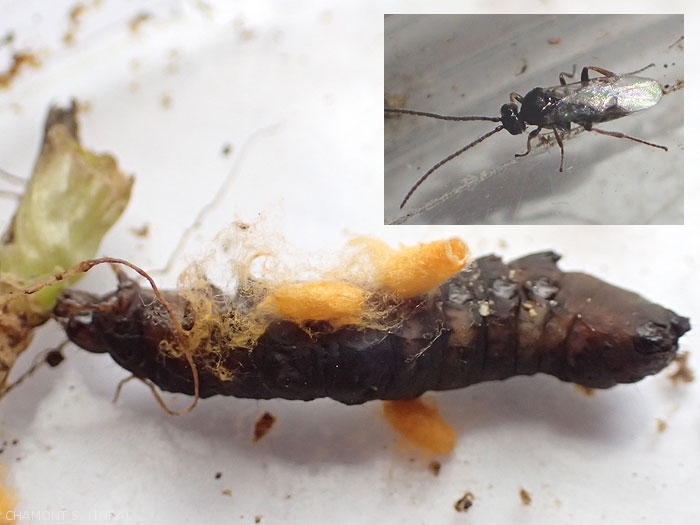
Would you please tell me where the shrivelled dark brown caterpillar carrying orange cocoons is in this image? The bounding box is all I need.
[54,252,690,404]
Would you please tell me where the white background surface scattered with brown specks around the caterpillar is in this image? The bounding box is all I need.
[0,0,700,524]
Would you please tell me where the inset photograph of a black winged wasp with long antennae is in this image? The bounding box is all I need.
[384,15,684,224]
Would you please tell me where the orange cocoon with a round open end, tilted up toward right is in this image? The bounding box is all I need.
[375,239,469,298]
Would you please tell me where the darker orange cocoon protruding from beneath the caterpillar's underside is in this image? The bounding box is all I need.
[384,399,456,454]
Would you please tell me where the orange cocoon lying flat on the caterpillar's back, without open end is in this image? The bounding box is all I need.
[259,281,365,328]
